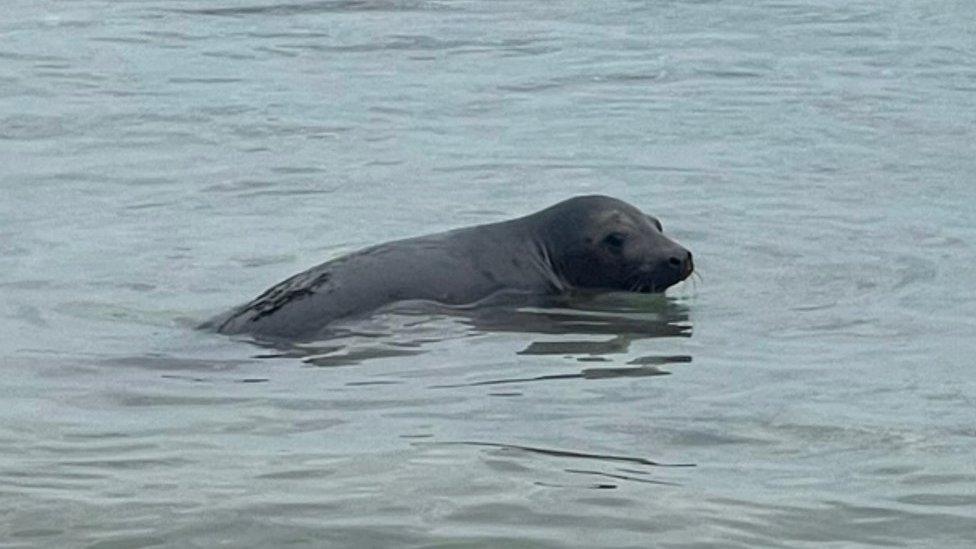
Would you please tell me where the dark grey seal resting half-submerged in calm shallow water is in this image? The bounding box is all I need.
[206,196,693,339]
